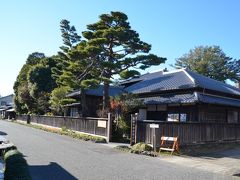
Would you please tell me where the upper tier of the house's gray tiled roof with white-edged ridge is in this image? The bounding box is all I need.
[126,69,240,95]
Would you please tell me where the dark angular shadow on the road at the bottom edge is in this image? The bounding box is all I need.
[29,162,77,180]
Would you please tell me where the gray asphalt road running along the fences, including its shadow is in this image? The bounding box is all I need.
[0,121,233,180]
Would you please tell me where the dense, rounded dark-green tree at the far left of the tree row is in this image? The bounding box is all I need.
[14,52,56,114]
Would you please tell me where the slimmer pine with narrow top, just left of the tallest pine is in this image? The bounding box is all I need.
[51,20,101,116]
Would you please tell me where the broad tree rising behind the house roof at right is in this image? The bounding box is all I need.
[175,46,240,81]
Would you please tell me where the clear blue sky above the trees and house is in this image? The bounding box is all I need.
[0,0,240,96]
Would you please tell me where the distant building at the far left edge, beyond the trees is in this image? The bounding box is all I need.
[0,94,15,119]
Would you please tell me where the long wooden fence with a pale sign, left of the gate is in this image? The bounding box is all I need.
[17,114,111,141]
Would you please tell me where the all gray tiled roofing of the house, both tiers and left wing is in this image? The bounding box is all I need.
[68,69,240,107]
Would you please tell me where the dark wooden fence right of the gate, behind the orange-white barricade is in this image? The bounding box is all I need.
[132,120,240,147]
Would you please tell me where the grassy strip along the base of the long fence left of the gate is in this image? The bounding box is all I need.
[14,121,107,143]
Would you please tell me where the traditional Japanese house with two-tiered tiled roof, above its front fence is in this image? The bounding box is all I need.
[121,69,240,123]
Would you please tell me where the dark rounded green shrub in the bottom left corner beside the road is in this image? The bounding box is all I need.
[4,150,32,180]
